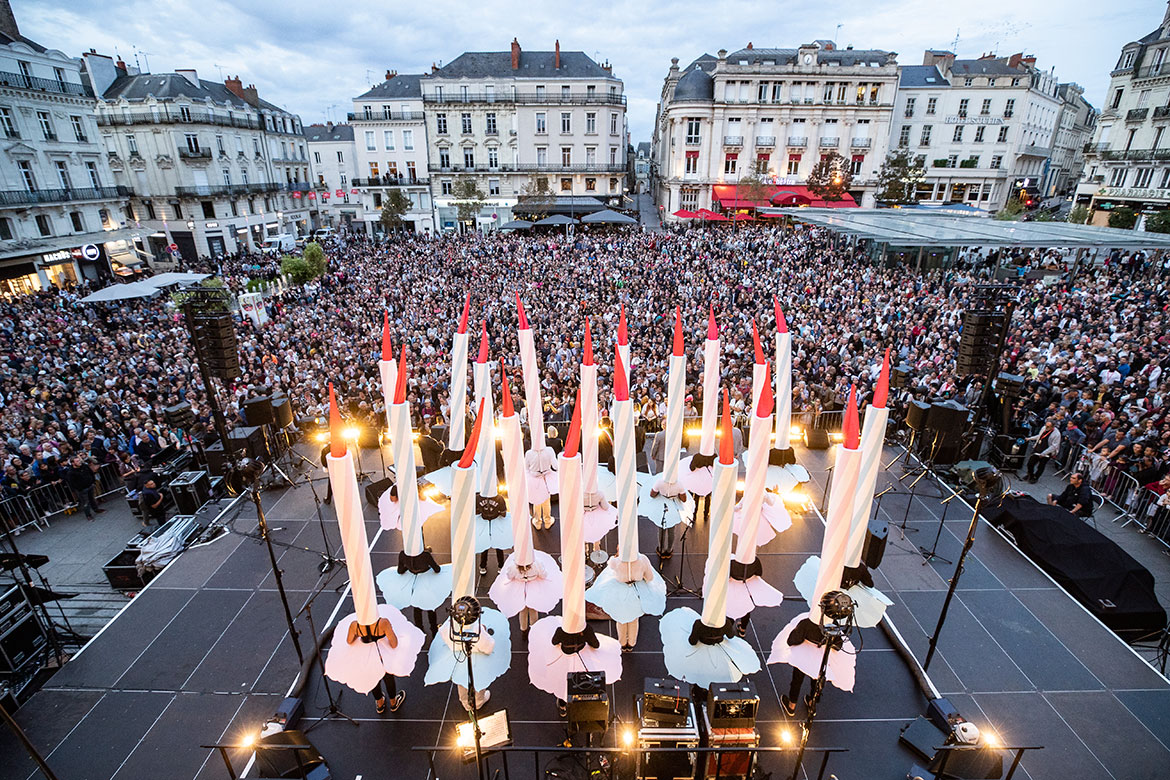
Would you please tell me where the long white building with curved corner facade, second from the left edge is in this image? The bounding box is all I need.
[83,53,316,261]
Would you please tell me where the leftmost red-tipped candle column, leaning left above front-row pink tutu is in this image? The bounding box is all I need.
[325,382,378,626]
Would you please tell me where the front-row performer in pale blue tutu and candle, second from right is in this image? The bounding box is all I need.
[659,391,759,688]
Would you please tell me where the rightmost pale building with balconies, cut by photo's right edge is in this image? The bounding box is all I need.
[1076,4,1170,225]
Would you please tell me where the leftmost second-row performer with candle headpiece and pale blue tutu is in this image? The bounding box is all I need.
[377,345,450,631]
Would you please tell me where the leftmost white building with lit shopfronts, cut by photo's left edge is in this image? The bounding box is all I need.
[0,2,140,296]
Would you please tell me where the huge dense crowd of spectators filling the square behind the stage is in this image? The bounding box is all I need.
[0,219,1170,528]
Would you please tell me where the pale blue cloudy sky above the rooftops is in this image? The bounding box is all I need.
[12,0,1166,143]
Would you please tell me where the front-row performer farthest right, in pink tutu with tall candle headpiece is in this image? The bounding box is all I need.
[768,388,861,715]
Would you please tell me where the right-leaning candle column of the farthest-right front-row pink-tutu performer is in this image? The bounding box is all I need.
[808,387,861,623]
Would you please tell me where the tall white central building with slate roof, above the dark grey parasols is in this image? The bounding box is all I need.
[420,40,627,230]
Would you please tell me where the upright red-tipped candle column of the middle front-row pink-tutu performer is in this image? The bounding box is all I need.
[558,391,585,634]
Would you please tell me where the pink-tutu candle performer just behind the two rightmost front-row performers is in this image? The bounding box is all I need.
[728,362,791,636]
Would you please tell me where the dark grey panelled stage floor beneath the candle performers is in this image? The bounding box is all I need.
[0,448,1170,780]
